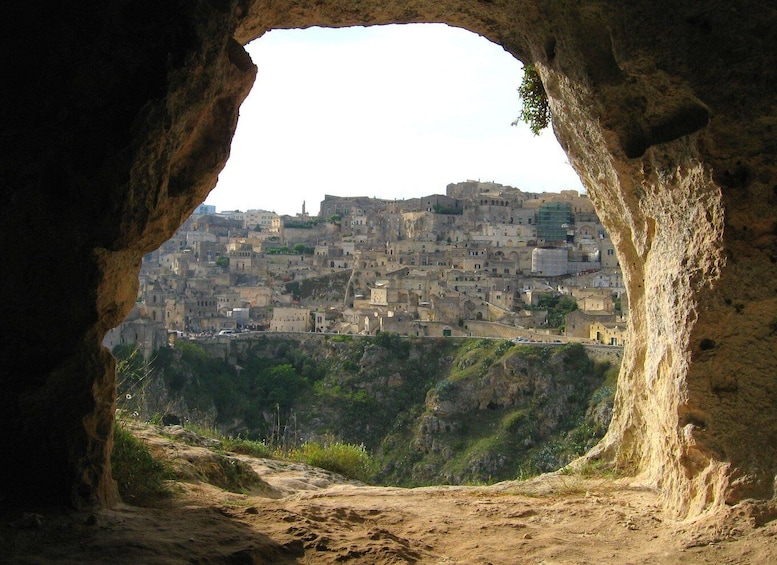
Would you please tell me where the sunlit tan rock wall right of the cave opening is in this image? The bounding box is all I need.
[532,5,777,516]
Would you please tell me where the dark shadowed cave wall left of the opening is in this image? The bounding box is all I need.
[0,0,256,507]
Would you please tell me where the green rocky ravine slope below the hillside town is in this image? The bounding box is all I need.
[113,334,617,486]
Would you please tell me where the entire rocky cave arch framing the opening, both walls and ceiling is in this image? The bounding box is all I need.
[0,0,777,516]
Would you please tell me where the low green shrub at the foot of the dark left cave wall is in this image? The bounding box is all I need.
[111,421,173,506]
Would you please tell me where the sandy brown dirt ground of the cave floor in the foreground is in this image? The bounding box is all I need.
[0,430,777,565]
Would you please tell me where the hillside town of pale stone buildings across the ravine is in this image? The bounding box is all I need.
[104,180,628,354]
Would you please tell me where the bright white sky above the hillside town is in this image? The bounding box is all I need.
[205,24,584,214]
